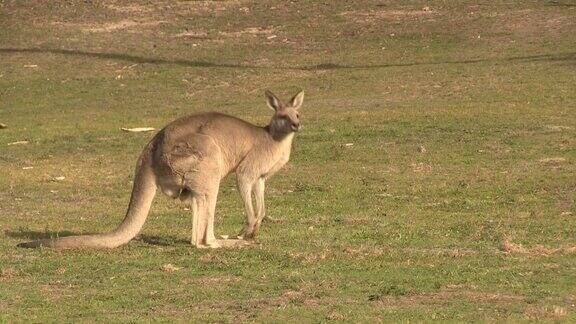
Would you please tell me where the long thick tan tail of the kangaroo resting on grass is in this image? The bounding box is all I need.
[18,140,157,249]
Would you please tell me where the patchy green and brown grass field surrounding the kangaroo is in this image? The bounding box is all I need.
[0,0,576,322]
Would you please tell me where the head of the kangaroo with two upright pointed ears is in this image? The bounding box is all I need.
[266,90,304,135]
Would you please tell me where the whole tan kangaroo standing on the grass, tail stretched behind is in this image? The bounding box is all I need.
[19,90,304,248]
